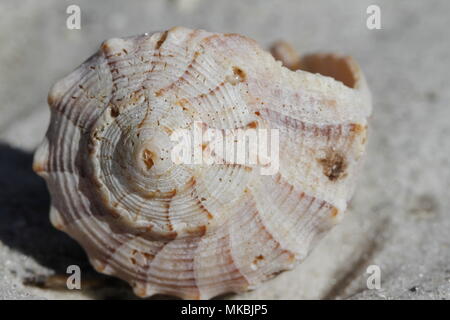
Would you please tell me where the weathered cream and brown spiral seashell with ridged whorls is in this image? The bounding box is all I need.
[33,27,371,299]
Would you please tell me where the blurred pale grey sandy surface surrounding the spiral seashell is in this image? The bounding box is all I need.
[0,0,450,299]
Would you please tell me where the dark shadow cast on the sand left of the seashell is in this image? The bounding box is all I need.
[0,143,133,299]
